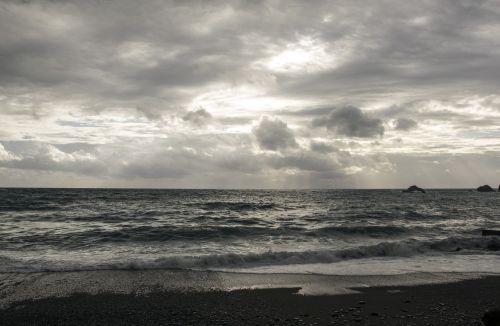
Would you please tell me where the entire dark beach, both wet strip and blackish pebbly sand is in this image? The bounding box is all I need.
[0,271,500,325]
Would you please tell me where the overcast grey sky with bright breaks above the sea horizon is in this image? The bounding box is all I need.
[0,0,500,188]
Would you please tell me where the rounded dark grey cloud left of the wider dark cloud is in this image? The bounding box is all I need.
[253,117,297,151]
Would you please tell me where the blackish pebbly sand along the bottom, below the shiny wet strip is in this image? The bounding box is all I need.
[0,277,500,325]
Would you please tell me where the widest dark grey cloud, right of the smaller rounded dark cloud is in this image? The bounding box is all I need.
[313,106,384,138]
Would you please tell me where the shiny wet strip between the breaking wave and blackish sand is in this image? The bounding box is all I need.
[0,269,494,308]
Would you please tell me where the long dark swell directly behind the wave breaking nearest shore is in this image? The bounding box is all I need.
[0,224,421,249]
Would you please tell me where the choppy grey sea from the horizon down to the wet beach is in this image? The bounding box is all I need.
[0,189,500,274]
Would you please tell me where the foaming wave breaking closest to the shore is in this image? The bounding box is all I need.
[0,237,500,271]
